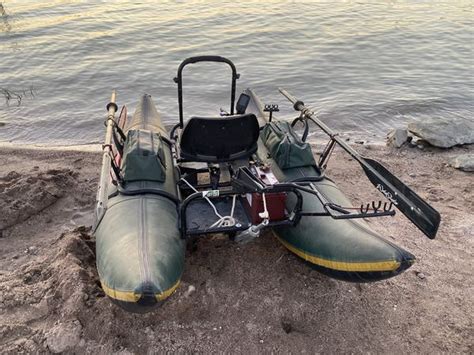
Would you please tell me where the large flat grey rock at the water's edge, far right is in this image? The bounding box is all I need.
[408,118,474,148]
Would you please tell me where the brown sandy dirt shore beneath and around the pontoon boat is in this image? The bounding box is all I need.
[0,145,474,354]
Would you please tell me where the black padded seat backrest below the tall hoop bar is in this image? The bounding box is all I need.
[180,114,260,163]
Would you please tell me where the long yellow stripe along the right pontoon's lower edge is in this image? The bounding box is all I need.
[273,232,400,272]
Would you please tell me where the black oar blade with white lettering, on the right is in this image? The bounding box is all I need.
[361,158,441,239]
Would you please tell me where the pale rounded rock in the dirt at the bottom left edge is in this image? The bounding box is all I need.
[46,320,82,353]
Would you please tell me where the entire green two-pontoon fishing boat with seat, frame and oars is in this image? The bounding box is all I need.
[94,56,440,312]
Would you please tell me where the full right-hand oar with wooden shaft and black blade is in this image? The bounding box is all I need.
[279,89,441,239]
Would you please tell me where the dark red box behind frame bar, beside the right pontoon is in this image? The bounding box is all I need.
[245,192,286,224]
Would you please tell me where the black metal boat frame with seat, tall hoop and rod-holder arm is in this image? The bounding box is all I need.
[170,56,395,238]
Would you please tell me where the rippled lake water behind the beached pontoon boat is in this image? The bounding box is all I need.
[0,0,474,145]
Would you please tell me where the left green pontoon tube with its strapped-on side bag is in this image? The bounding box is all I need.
[94,95,185,312]
